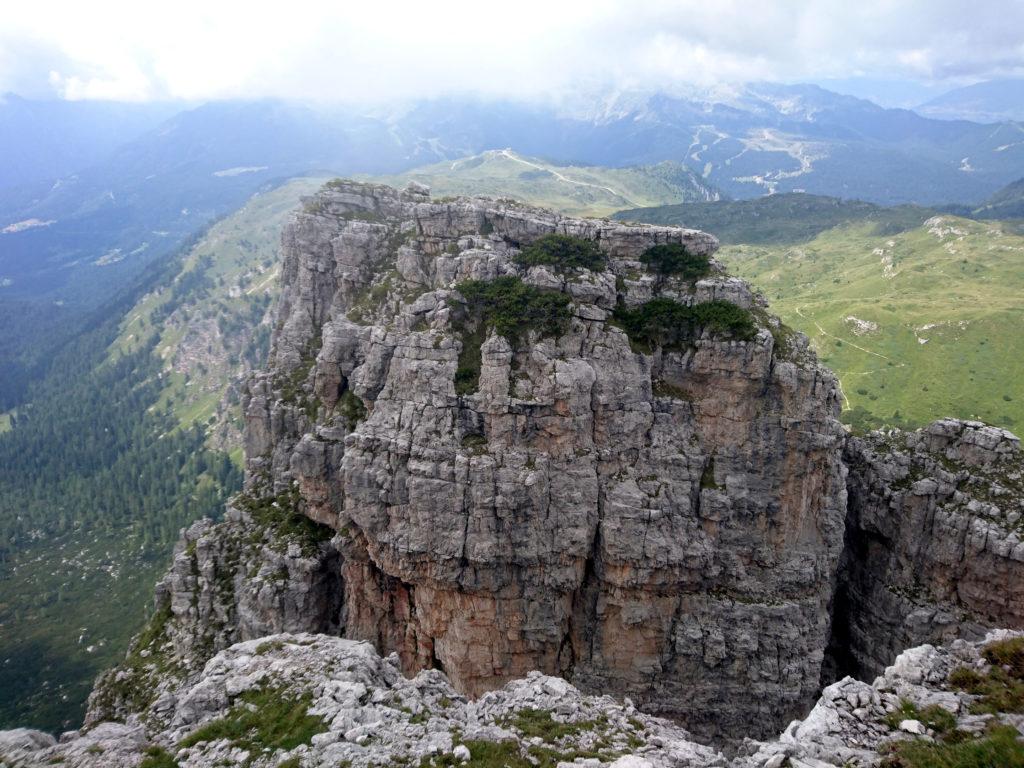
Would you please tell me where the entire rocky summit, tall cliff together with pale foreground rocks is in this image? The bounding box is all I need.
[0,181,1024,768]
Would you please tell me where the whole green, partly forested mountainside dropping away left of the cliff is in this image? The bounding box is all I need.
[0,178,323,731]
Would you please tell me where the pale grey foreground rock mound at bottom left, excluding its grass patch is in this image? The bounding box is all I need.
[9,634,725,768]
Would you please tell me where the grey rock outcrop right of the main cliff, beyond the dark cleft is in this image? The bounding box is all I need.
[833,419,1024,677]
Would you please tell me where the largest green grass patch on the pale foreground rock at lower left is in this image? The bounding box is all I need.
[180,687,327,753]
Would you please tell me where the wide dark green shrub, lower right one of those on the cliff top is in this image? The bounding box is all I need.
[612,298,757,351]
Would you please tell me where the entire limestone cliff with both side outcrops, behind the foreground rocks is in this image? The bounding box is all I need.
[87,182,1024,759]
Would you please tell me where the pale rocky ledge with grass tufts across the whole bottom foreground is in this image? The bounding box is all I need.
[0,632,1024,768]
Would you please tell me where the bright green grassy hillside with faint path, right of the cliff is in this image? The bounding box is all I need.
[720,216,1024,428]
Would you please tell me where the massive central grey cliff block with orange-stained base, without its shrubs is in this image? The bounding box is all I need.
[226,183,846,734]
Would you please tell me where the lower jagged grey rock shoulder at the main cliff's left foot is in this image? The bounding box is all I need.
[85,512,342,727]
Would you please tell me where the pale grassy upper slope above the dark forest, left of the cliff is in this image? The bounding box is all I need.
[109,177,326,456]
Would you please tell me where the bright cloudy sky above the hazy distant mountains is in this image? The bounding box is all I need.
[0,0,1024,101]
